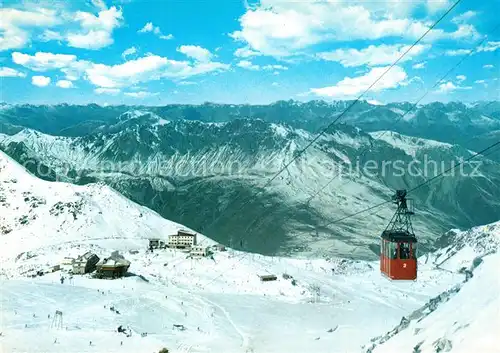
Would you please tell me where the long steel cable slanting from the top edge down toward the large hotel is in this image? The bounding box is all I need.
[195,0,462,242]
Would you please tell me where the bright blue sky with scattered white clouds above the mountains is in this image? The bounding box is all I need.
[0,0,500,105]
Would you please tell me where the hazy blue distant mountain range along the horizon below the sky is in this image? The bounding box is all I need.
[0,100,500,159]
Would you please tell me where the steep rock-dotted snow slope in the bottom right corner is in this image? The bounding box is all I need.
[367,222,500,353]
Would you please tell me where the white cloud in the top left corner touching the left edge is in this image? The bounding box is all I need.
[0,8,61,51]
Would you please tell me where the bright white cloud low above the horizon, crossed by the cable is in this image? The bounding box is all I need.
[310,66,408,99]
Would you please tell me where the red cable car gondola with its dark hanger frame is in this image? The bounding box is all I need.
[380,190,417,280]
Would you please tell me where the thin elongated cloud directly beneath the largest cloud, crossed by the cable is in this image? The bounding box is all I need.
[317,44,430,67]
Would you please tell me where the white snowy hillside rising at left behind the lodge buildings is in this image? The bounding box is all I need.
[0,152,213,261]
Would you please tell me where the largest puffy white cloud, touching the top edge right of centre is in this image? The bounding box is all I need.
[230,0,478,57]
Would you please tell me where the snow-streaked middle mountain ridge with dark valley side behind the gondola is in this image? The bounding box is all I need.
[0,110,500,258]
